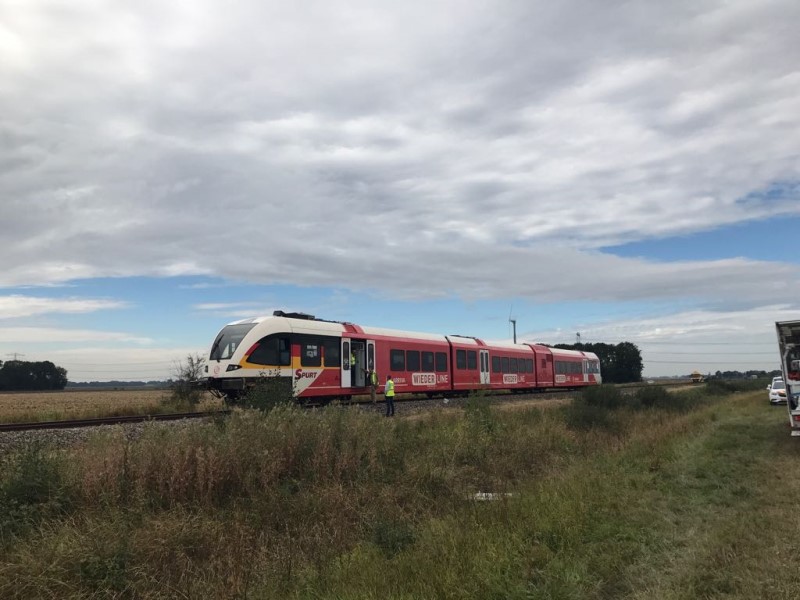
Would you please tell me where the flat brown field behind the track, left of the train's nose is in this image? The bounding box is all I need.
[0,390,222,423]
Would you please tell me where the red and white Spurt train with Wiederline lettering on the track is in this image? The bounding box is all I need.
[205,311,602,400]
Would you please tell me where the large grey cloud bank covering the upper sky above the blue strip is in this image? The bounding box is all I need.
[0,0,800,302]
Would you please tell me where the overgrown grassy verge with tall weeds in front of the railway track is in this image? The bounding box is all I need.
[0,386,800,599]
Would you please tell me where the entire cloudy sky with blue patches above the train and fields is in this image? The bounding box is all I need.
[0,0,800,381]
